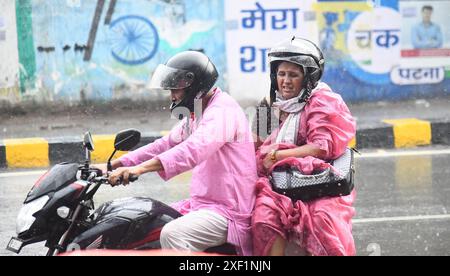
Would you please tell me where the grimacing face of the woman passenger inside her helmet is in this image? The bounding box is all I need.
[277,61,305,100]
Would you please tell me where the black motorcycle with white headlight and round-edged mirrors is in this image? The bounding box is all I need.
[6,129,236,256]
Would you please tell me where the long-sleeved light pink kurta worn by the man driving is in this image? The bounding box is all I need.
[120,88,257,255]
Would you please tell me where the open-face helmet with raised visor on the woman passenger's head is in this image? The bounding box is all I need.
[269,36,325,102]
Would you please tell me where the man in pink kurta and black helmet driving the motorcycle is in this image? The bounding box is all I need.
[100,51,257,255]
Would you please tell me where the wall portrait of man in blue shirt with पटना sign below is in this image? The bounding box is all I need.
[391,1,450,85]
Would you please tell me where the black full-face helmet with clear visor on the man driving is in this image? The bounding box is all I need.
[150,51,219,112]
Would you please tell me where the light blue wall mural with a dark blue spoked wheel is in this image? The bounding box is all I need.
[32,0,226,101]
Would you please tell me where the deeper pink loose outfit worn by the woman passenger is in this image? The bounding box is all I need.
[252,83,356,256]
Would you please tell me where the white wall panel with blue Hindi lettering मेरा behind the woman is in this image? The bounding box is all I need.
[224,0,317,100]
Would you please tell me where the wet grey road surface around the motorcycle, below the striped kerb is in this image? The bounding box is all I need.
[0,147,450,256]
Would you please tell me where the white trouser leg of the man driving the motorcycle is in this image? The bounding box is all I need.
[160,210,228,252]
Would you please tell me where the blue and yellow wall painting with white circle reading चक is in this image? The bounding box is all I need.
[315,0,450,102]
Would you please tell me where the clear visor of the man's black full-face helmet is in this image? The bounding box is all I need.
[148,64,194,90]
